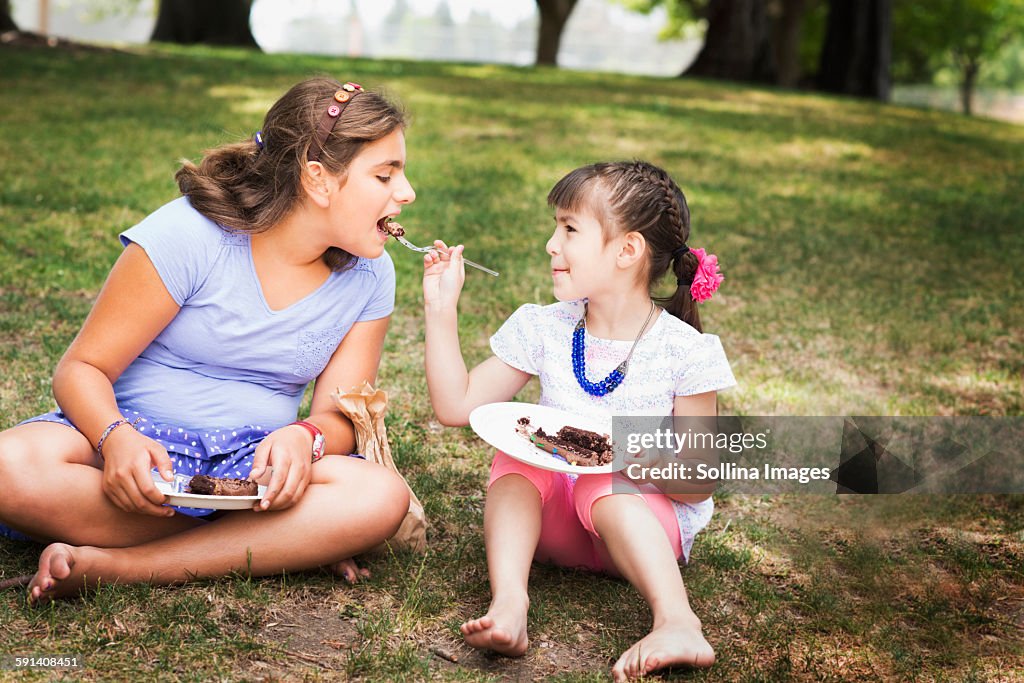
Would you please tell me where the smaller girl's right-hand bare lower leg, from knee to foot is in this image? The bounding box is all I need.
[591,494,715,681]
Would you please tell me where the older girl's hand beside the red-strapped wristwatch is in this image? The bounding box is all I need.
[249,425,312,512]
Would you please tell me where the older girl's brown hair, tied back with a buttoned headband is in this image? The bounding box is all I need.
[174,78,406,270]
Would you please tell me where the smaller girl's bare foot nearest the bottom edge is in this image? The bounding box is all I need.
[611,622,715,681]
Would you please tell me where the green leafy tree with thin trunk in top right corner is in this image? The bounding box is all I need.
[893,0,1024,115]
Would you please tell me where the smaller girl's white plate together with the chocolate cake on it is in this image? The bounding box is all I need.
[469,402,612,474]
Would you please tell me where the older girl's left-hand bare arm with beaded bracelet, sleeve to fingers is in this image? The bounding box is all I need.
[53,243,179,516]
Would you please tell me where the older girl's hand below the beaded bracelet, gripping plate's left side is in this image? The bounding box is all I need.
[102,425,174,517]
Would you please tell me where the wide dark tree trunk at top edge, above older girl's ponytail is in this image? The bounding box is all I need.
[150,0,258,47]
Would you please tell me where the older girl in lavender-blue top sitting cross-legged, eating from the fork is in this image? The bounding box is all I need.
[0,79,416,602]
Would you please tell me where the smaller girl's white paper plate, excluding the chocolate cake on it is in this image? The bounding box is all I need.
[469,402,612,474]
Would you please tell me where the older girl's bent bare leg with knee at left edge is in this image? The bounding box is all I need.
[0,422,201,548]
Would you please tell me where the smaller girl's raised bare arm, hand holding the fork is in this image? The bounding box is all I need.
[423,241,531,427]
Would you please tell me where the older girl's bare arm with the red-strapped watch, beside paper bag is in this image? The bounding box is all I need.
[251,316,391,510]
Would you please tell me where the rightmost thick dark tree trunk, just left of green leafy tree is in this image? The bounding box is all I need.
[818,0,892,101]
